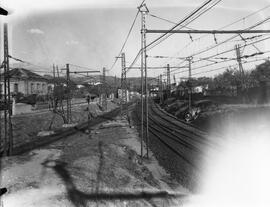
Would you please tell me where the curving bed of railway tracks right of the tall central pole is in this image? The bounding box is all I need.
[134,101,219,187]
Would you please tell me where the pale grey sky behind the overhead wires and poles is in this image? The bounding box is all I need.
[0,0,270,79]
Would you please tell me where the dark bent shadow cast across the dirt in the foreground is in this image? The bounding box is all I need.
[42,160,186,207]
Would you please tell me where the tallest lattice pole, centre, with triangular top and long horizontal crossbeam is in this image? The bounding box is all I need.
[138,4,149,158]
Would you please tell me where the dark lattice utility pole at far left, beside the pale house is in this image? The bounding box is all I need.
[4,23,13,155]
